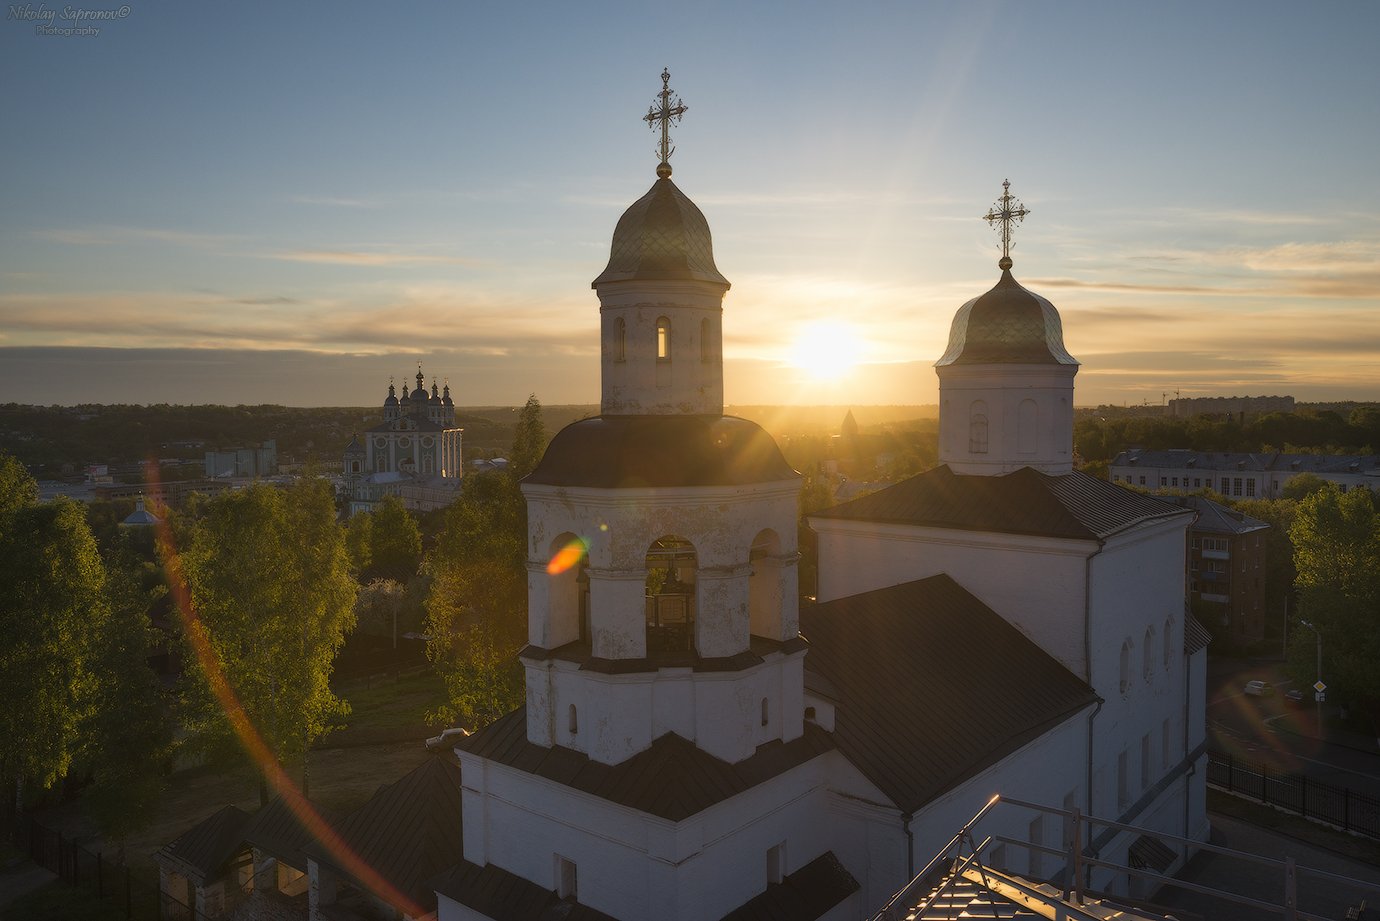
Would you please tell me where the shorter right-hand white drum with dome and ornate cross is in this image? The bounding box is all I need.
[934,181,1078,475]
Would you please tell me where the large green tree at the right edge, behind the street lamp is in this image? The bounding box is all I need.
[1289,486,1380,717]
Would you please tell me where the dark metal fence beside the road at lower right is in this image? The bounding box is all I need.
[1208,750,1380,838]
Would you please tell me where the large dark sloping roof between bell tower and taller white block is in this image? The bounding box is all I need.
[800,576,1098,812]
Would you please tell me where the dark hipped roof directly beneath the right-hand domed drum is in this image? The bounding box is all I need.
[811,465,1192,540]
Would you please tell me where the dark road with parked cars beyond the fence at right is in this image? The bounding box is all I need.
[1208,660,1380,798]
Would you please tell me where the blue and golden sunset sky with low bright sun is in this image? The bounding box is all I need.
[0,0,1380,406]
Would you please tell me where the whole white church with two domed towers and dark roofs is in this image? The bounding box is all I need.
[422,73,1208,921]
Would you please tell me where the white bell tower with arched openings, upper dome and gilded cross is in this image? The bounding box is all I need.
[516,72,805,762]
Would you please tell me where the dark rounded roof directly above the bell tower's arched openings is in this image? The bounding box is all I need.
[523,416,799,489]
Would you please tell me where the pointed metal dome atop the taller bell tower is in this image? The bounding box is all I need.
[592,170,729,287]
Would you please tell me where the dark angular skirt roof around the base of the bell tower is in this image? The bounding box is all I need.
[455,708,834,822]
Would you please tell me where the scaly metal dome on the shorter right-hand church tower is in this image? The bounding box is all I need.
[936,268,1078,366]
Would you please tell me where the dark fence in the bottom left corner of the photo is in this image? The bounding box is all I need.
[14,816,196,921]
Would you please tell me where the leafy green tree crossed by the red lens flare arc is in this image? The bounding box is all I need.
[170,481,357,801]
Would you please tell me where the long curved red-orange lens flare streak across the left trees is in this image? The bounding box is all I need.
[146,464,422,917]
